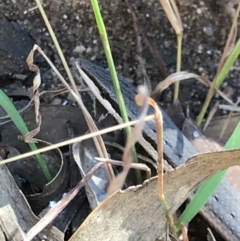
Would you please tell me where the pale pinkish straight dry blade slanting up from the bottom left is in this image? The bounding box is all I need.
[22,162,103,241]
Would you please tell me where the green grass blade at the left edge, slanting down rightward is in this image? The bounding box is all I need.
[0,90,52,182]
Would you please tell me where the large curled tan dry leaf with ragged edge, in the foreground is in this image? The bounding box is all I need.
[70,150,240,241]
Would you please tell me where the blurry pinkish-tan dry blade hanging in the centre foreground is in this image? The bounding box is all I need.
[107,86,148,196]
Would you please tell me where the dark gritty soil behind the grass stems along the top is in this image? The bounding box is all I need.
[0,0,240,240]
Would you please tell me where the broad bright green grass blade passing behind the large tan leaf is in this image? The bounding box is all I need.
[176,122,240,230]
